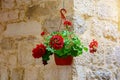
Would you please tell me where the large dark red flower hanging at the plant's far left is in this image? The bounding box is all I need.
[32,44,46,58]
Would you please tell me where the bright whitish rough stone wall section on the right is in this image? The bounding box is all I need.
[72,0,120,80]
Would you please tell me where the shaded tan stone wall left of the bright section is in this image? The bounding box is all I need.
[0,0,73,80]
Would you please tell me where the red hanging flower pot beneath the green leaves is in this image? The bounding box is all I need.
[54,55,73,66]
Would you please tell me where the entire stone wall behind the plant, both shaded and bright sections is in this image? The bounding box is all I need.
[0,0,120,80]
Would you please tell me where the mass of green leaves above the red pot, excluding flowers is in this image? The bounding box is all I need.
[43,30,88,60]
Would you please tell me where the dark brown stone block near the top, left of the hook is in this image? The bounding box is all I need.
[25,1,58,19]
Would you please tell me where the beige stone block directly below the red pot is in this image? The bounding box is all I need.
[44,64,72,80]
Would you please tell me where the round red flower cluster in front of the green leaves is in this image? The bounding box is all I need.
[50,35,64,50]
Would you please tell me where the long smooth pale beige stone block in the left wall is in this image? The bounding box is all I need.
[3,21,42,36]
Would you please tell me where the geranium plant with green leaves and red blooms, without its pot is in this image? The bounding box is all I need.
[32,8,88,65]
